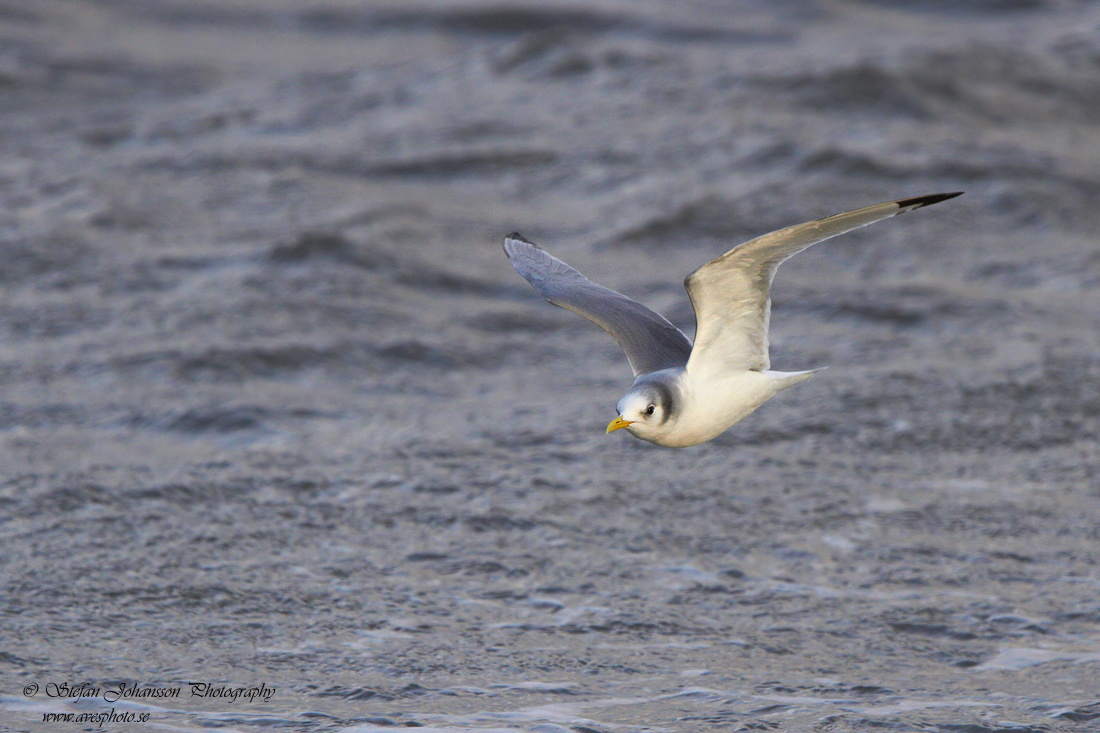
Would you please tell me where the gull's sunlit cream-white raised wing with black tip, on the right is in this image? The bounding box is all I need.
[684,192,961,374]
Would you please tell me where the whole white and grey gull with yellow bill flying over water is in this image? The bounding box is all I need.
[504,192,963,448]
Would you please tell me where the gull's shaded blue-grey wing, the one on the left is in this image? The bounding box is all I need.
[504,233,691,376]
